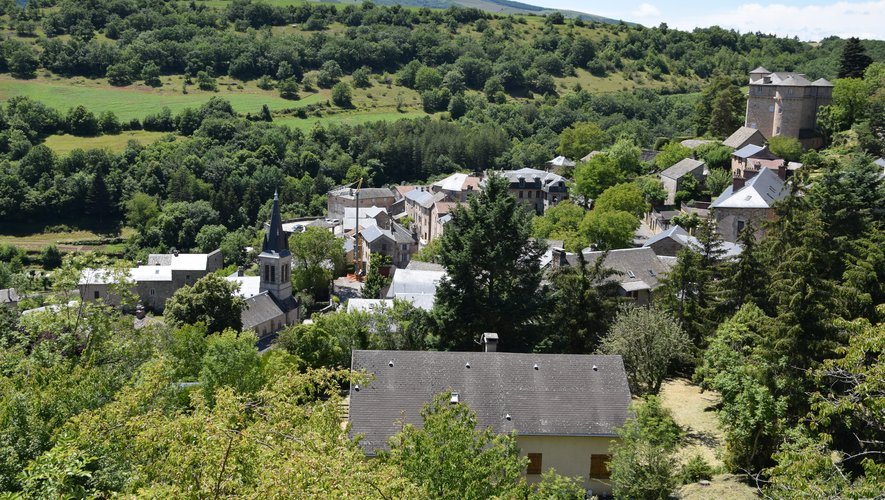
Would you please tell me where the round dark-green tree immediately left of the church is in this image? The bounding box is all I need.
[165,274,246,333]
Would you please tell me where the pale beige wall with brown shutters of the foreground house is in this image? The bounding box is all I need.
[516,435,614,495]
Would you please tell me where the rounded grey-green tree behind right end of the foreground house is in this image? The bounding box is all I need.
[600,306,691,394]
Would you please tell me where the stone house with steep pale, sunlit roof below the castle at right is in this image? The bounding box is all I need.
[710,168,789,242]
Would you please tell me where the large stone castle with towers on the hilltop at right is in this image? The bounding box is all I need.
[744,66,833,148]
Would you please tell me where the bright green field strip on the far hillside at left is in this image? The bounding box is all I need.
[0,75,325,120]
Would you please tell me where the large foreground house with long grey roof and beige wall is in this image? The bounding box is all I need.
[348,348,631,494]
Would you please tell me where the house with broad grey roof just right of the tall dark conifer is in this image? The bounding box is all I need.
[552,247,675,305]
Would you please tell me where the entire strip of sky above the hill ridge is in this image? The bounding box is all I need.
[523,0,885,41]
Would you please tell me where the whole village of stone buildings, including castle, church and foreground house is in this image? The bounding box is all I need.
[0,57,885,496]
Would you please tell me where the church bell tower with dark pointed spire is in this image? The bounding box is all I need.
[258,193,292,303]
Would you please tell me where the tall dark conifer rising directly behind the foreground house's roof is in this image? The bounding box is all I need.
[435,175,544,350]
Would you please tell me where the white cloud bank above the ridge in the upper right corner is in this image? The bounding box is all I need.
[668,0,885,40]
